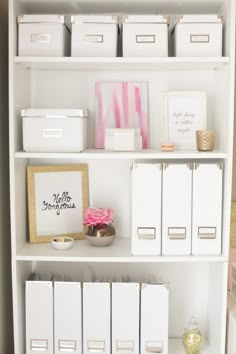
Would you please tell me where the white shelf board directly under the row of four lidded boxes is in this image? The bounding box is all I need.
[14,57,229,71]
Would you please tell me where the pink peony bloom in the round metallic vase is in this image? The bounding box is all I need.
[84,208,114,226]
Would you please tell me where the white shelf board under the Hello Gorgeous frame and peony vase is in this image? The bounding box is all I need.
[16,237,227,263]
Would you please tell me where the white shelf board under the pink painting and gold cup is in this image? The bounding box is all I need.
[15,149,227,160]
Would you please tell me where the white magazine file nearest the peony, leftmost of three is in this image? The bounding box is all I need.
[131,163,162,255]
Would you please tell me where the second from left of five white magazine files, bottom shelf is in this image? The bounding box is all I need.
[54,281,82,354]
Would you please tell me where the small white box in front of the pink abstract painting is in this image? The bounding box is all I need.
[105,128,142,151]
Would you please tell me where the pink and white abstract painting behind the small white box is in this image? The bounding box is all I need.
[95,81,148,148]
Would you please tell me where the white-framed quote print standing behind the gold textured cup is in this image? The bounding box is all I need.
[163,91,206,150]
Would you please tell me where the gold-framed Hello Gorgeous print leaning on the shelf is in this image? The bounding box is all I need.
[27,164,89,243]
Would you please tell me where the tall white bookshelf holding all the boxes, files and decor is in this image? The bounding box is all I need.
[9,0,235,354]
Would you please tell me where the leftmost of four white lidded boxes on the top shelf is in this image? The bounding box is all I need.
[18,15,70,57]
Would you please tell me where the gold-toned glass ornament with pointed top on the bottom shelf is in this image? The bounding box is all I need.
[182,316,203,354]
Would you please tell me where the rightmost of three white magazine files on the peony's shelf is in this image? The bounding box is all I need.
[192,163,223,255]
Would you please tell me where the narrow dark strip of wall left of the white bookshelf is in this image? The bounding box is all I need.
[0,0,13,354]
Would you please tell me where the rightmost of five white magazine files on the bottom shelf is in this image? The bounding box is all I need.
[140,284,169,354]
